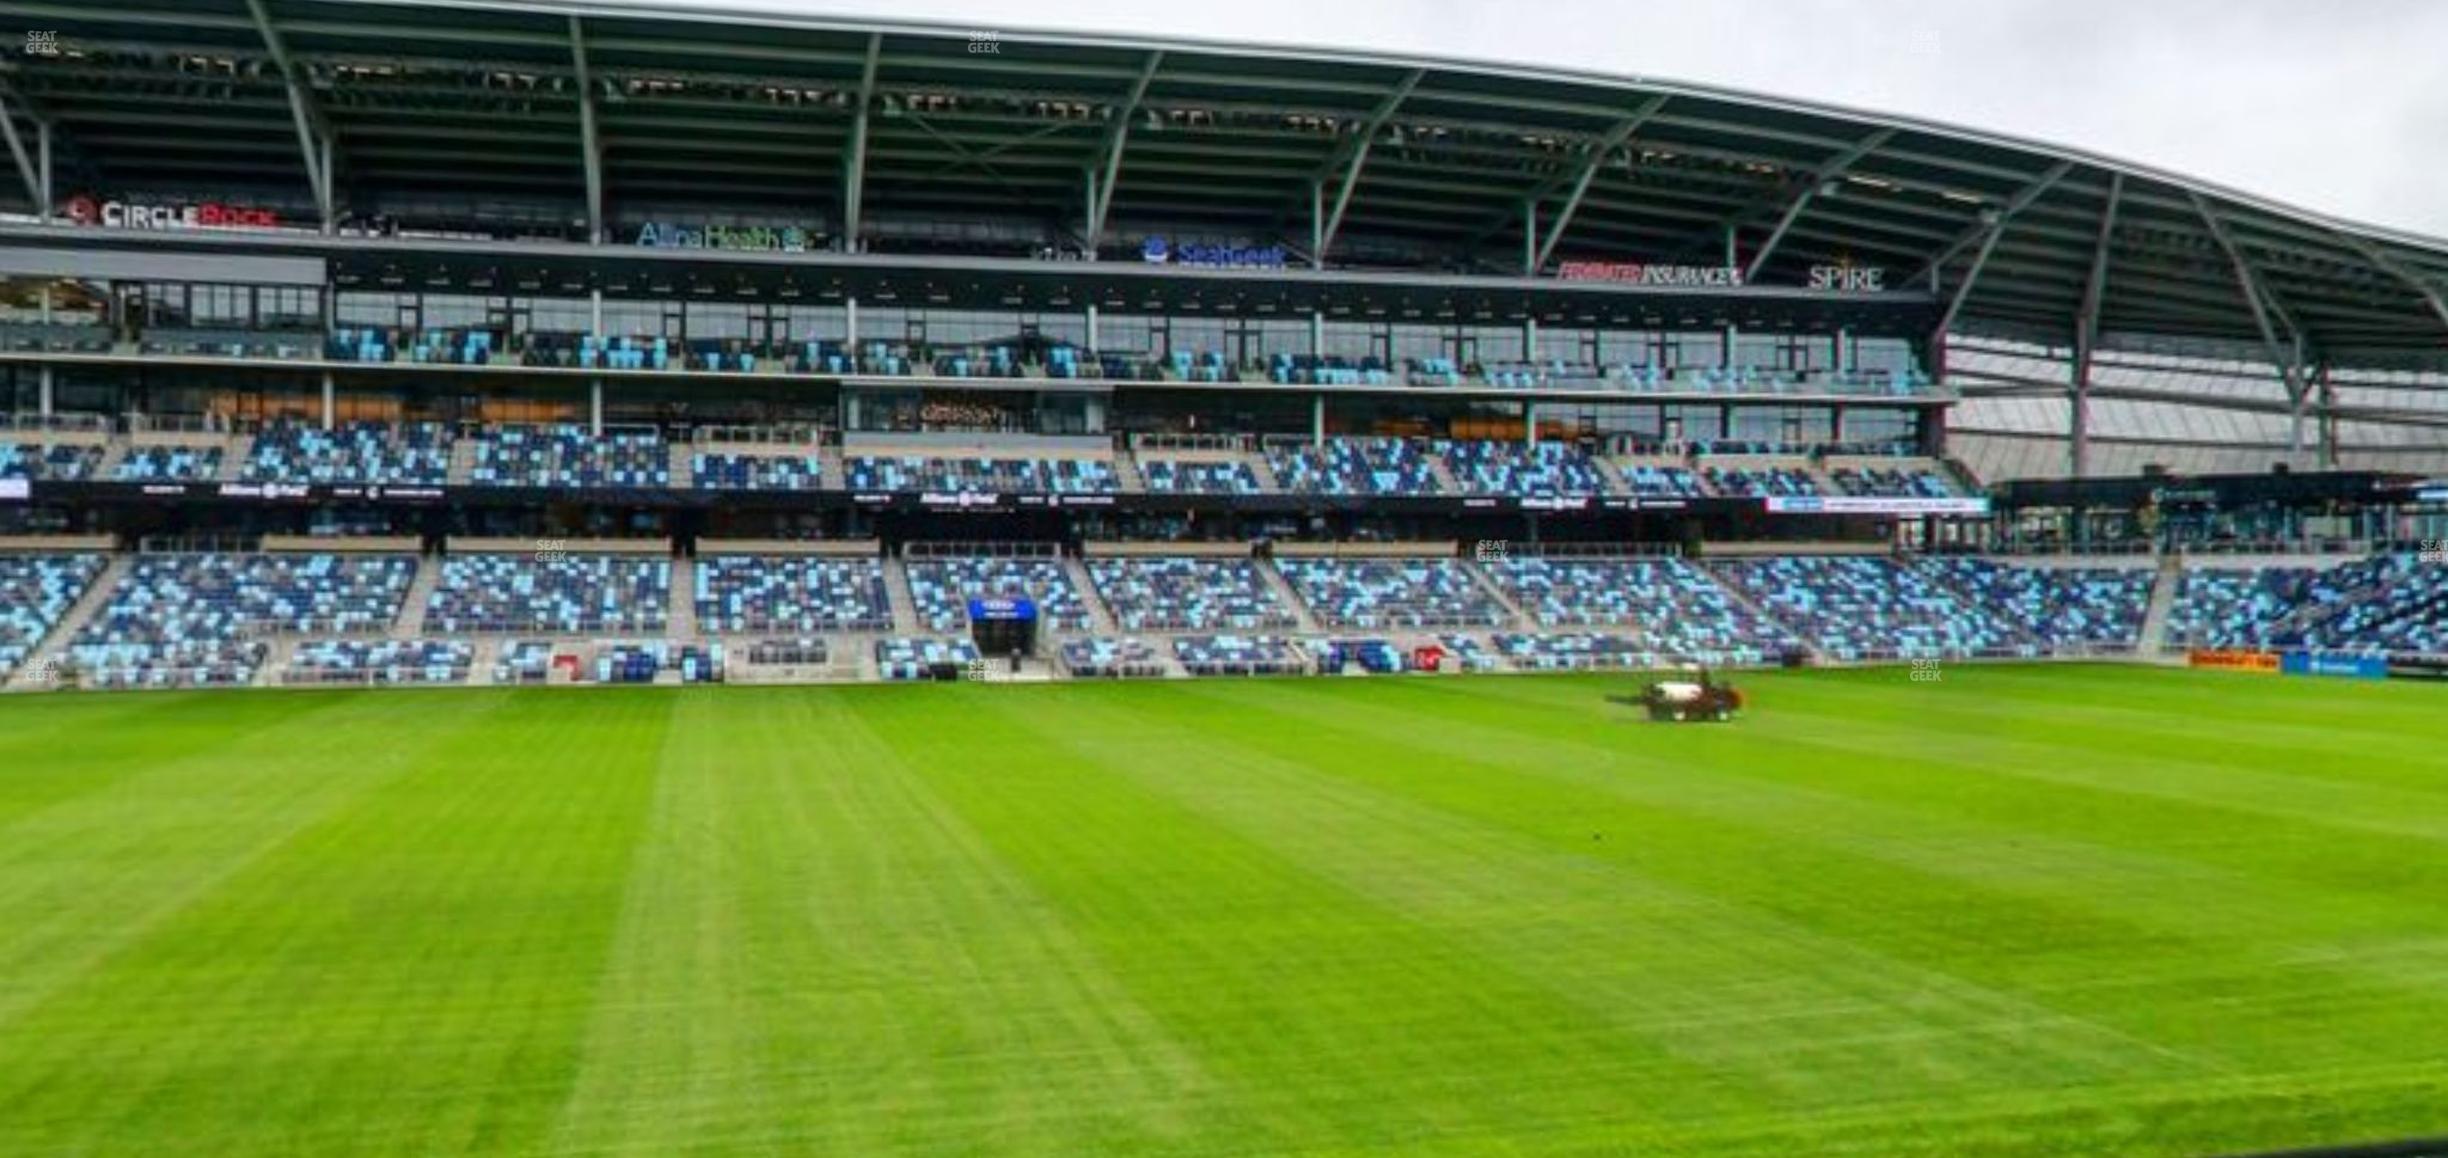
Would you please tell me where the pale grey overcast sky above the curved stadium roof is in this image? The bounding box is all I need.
[636,0,2448,237]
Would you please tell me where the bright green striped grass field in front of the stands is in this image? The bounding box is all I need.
[0,668,2448,1156]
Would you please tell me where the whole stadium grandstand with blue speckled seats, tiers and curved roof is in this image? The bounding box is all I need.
[0,0,2448,685]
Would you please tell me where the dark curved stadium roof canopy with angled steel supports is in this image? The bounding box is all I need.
[0,0,2448,365]
